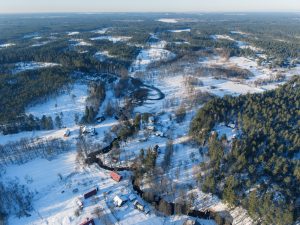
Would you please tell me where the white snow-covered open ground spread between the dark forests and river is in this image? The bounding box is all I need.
[0,29,300,225]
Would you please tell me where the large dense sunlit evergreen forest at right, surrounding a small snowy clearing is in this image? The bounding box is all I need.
[190,77,300,225]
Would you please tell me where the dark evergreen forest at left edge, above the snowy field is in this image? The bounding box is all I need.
[0,68,72,124]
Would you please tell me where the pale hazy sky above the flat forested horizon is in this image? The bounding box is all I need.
[0,0,300,13]
